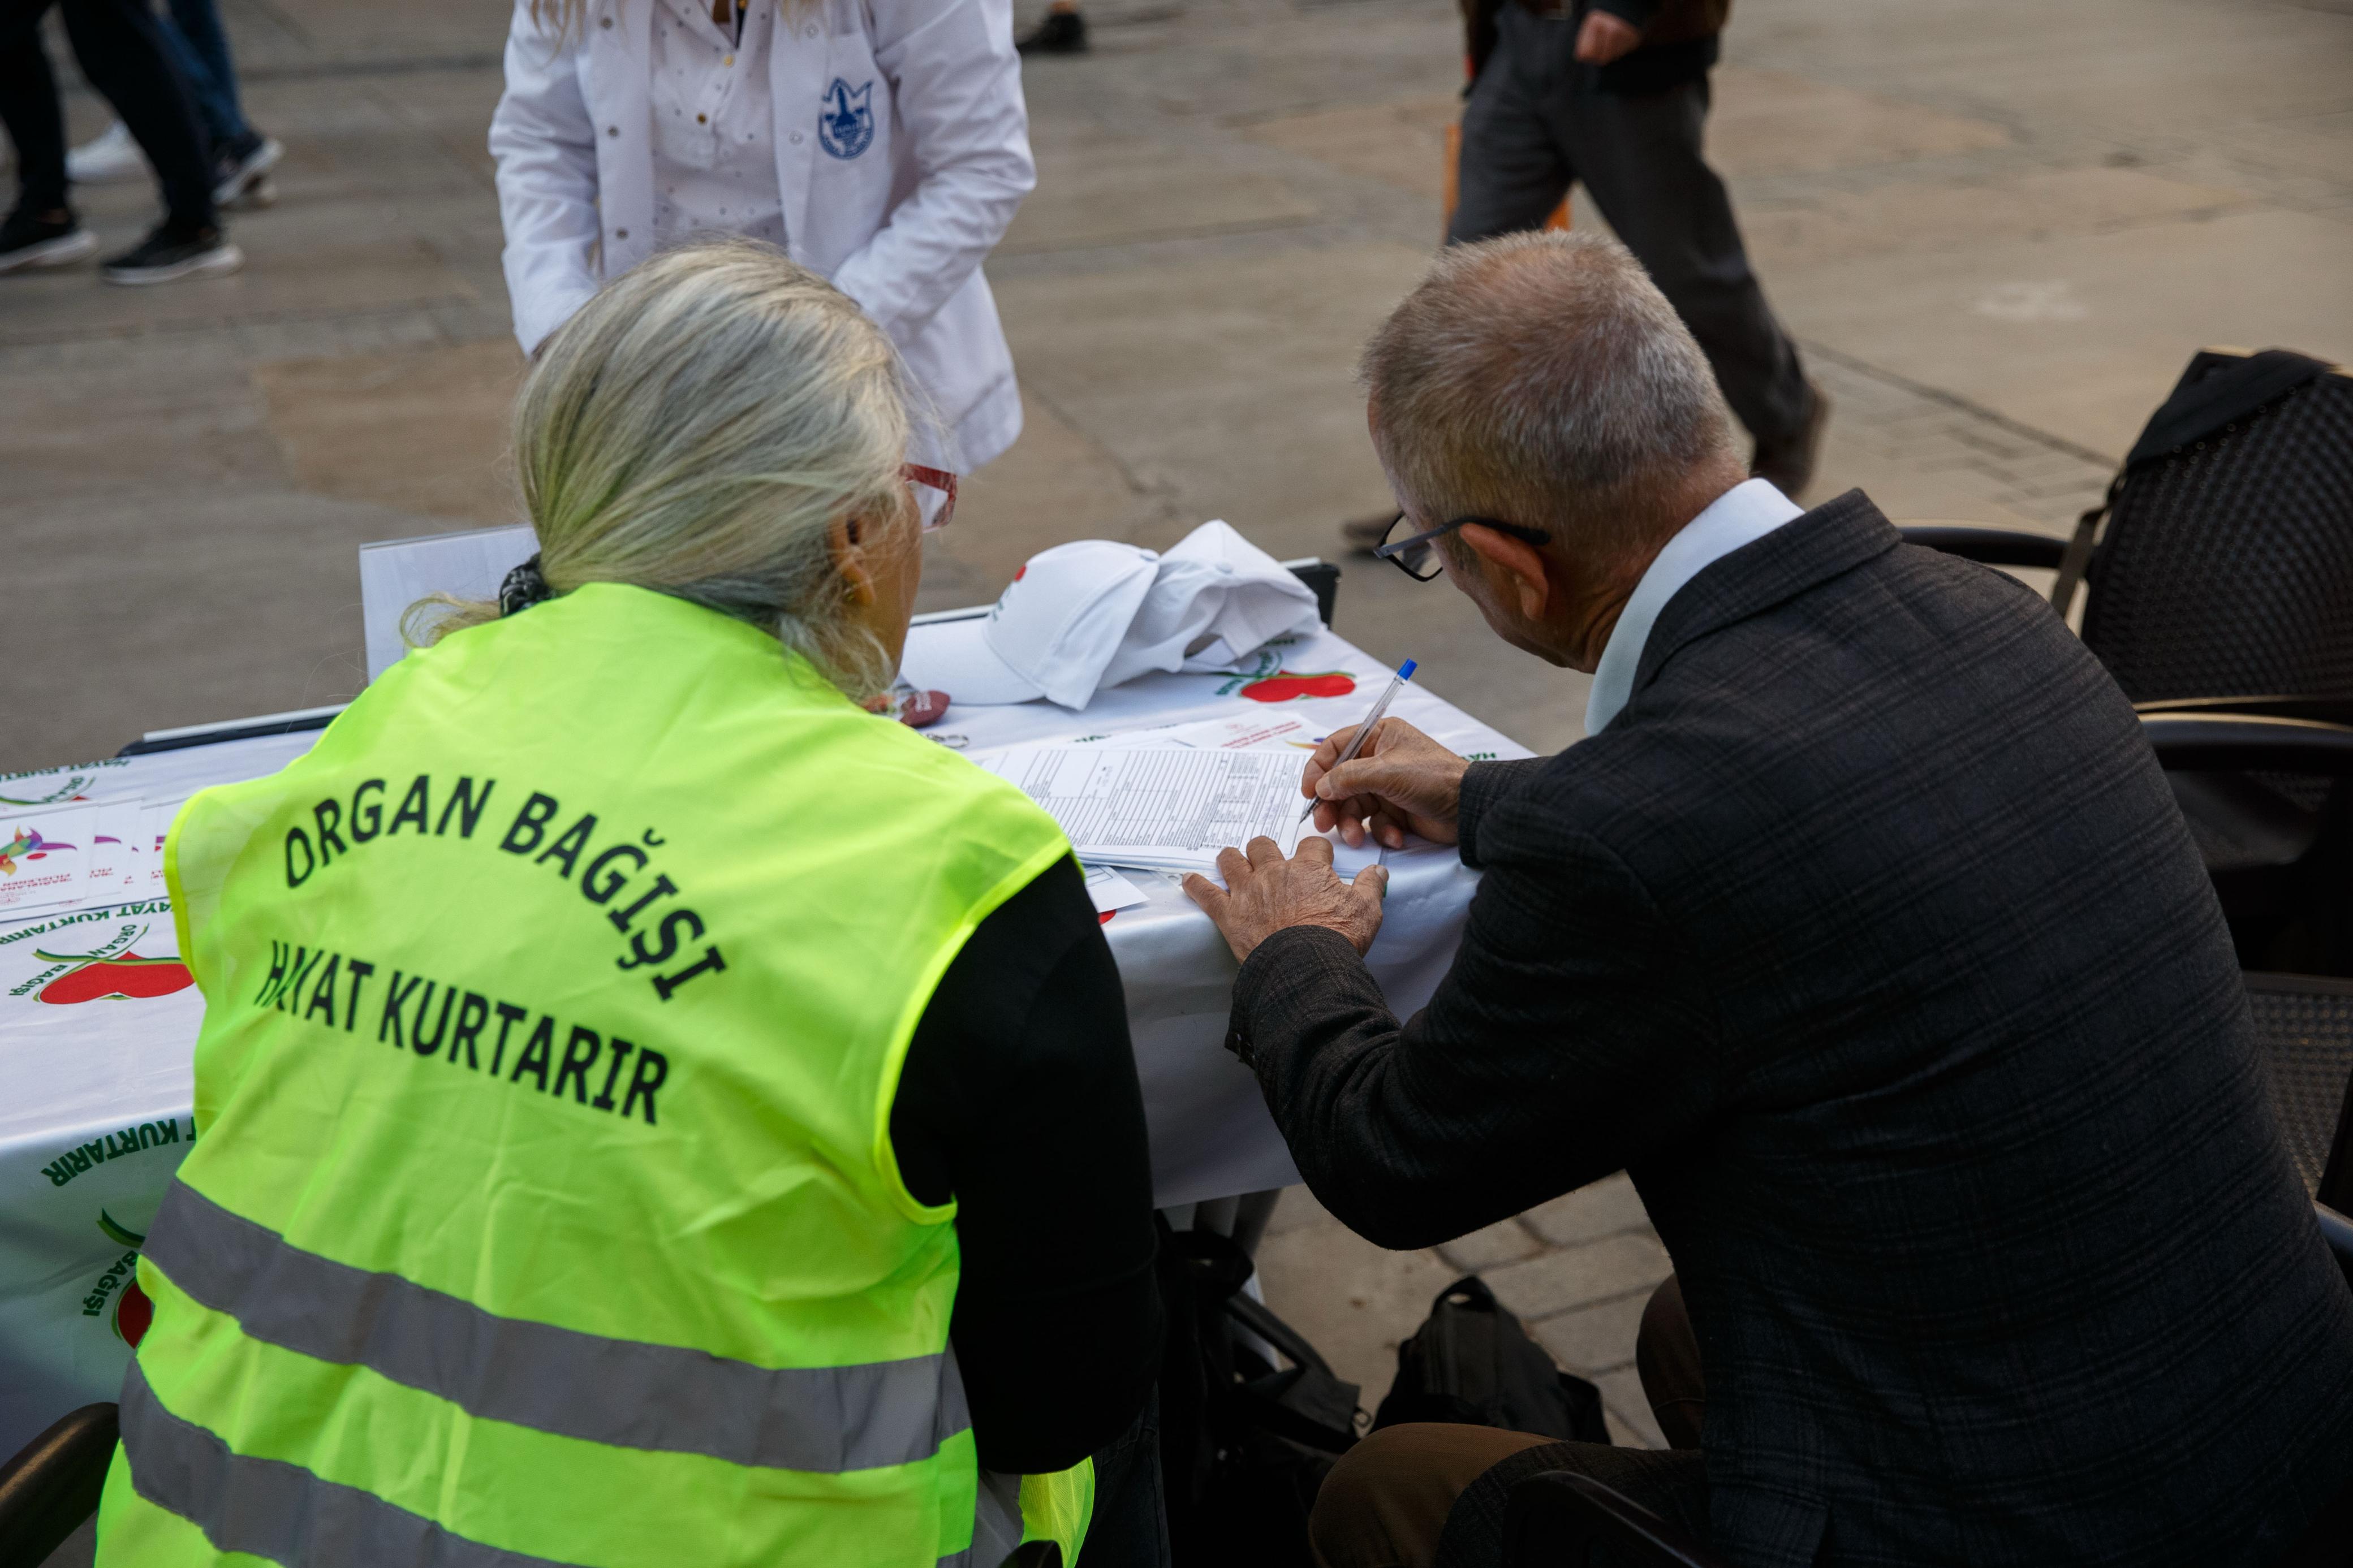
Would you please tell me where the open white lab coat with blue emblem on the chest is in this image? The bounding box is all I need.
[489,0,1038,473]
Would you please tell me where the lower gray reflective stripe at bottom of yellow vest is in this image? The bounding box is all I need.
[122,1361,583,1568]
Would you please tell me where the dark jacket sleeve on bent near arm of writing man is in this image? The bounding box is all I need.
[1229,799,1718,1249]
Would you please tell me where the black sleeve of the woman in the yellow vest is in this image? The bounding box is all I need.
[889,861,1160,1474]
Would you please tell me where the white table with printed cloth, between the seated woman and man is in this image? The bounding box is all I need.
[0,625,1529,1458]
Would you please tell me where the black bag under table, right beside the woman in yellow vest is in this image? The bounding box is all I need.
[1160,1220,1360,1568]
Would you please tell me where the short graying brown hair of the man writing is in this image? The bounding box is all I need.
[1358,233,1734,555]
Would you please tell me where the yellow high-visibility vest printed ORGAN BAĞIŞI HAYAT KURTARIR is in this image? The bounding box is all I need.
[85,585,1094,1568]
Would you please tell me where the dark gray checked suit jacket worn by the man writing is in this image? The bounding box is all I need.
[1233,491,2353,1568]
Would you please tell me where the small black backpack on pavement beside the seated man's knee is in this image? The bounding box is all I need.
[1372,1274,1609,1444]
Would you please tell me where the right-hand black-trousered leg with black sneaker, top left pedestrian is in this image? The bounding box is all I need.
[53,0,245,284]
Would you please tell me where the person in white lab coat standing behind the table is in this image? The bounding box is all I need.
[489,0,1038,473]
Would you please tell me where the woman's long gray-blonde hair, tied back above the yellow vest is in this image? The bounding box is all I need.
[402,240,917,698]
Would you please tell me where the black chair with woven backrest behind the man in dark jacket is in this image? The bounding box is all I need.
[1903,348,2353,975]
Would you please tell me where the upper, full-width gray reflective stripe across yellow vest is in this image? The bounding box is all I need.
[146,1180,972,1474]
